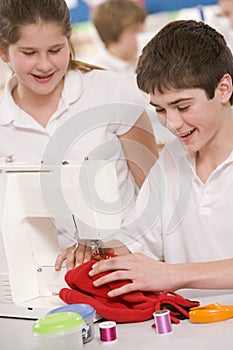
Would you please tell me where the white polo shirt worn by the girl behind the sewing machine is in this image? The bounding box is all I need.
[0,70,147,231]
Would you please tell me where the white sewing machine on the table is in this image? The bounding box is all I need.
[0,161,121,319]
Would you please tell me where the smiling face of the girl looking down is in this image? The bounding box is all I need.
[3,23,70,95]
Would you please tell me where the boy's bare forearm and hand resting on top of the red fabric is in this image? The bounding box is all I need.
[90,253,233,297]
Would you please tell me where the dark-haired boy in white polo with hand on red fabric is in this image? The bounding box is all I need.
[90,20,233,297]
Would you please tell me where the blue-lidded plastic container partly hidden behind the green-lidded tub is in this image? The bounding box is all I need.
[47,304,96,343]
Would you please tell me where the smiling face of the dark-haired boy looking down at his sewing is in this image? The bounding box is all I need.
[150,83,232,156]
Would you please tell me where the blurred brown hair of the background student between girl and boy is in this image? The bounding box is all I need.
[91,0,147,47]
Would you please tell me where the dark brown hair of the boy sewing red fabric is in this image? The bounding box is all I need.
[136,20,233,104]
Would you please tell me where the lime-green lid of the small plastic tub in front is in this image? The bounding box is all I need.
[32,312,83,335]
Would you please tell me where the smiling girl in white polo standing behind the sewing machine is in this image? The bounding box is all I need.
[0,0,157,252]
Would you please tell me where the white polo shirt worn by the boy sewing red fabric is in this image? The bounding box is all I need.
[121,141,233,263]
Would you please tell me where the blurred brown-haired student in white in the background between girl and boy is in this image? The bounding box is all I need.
[91,0,147,82]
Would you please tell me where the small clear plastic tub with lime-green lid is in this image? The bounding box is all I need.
[32,312,83,350]
